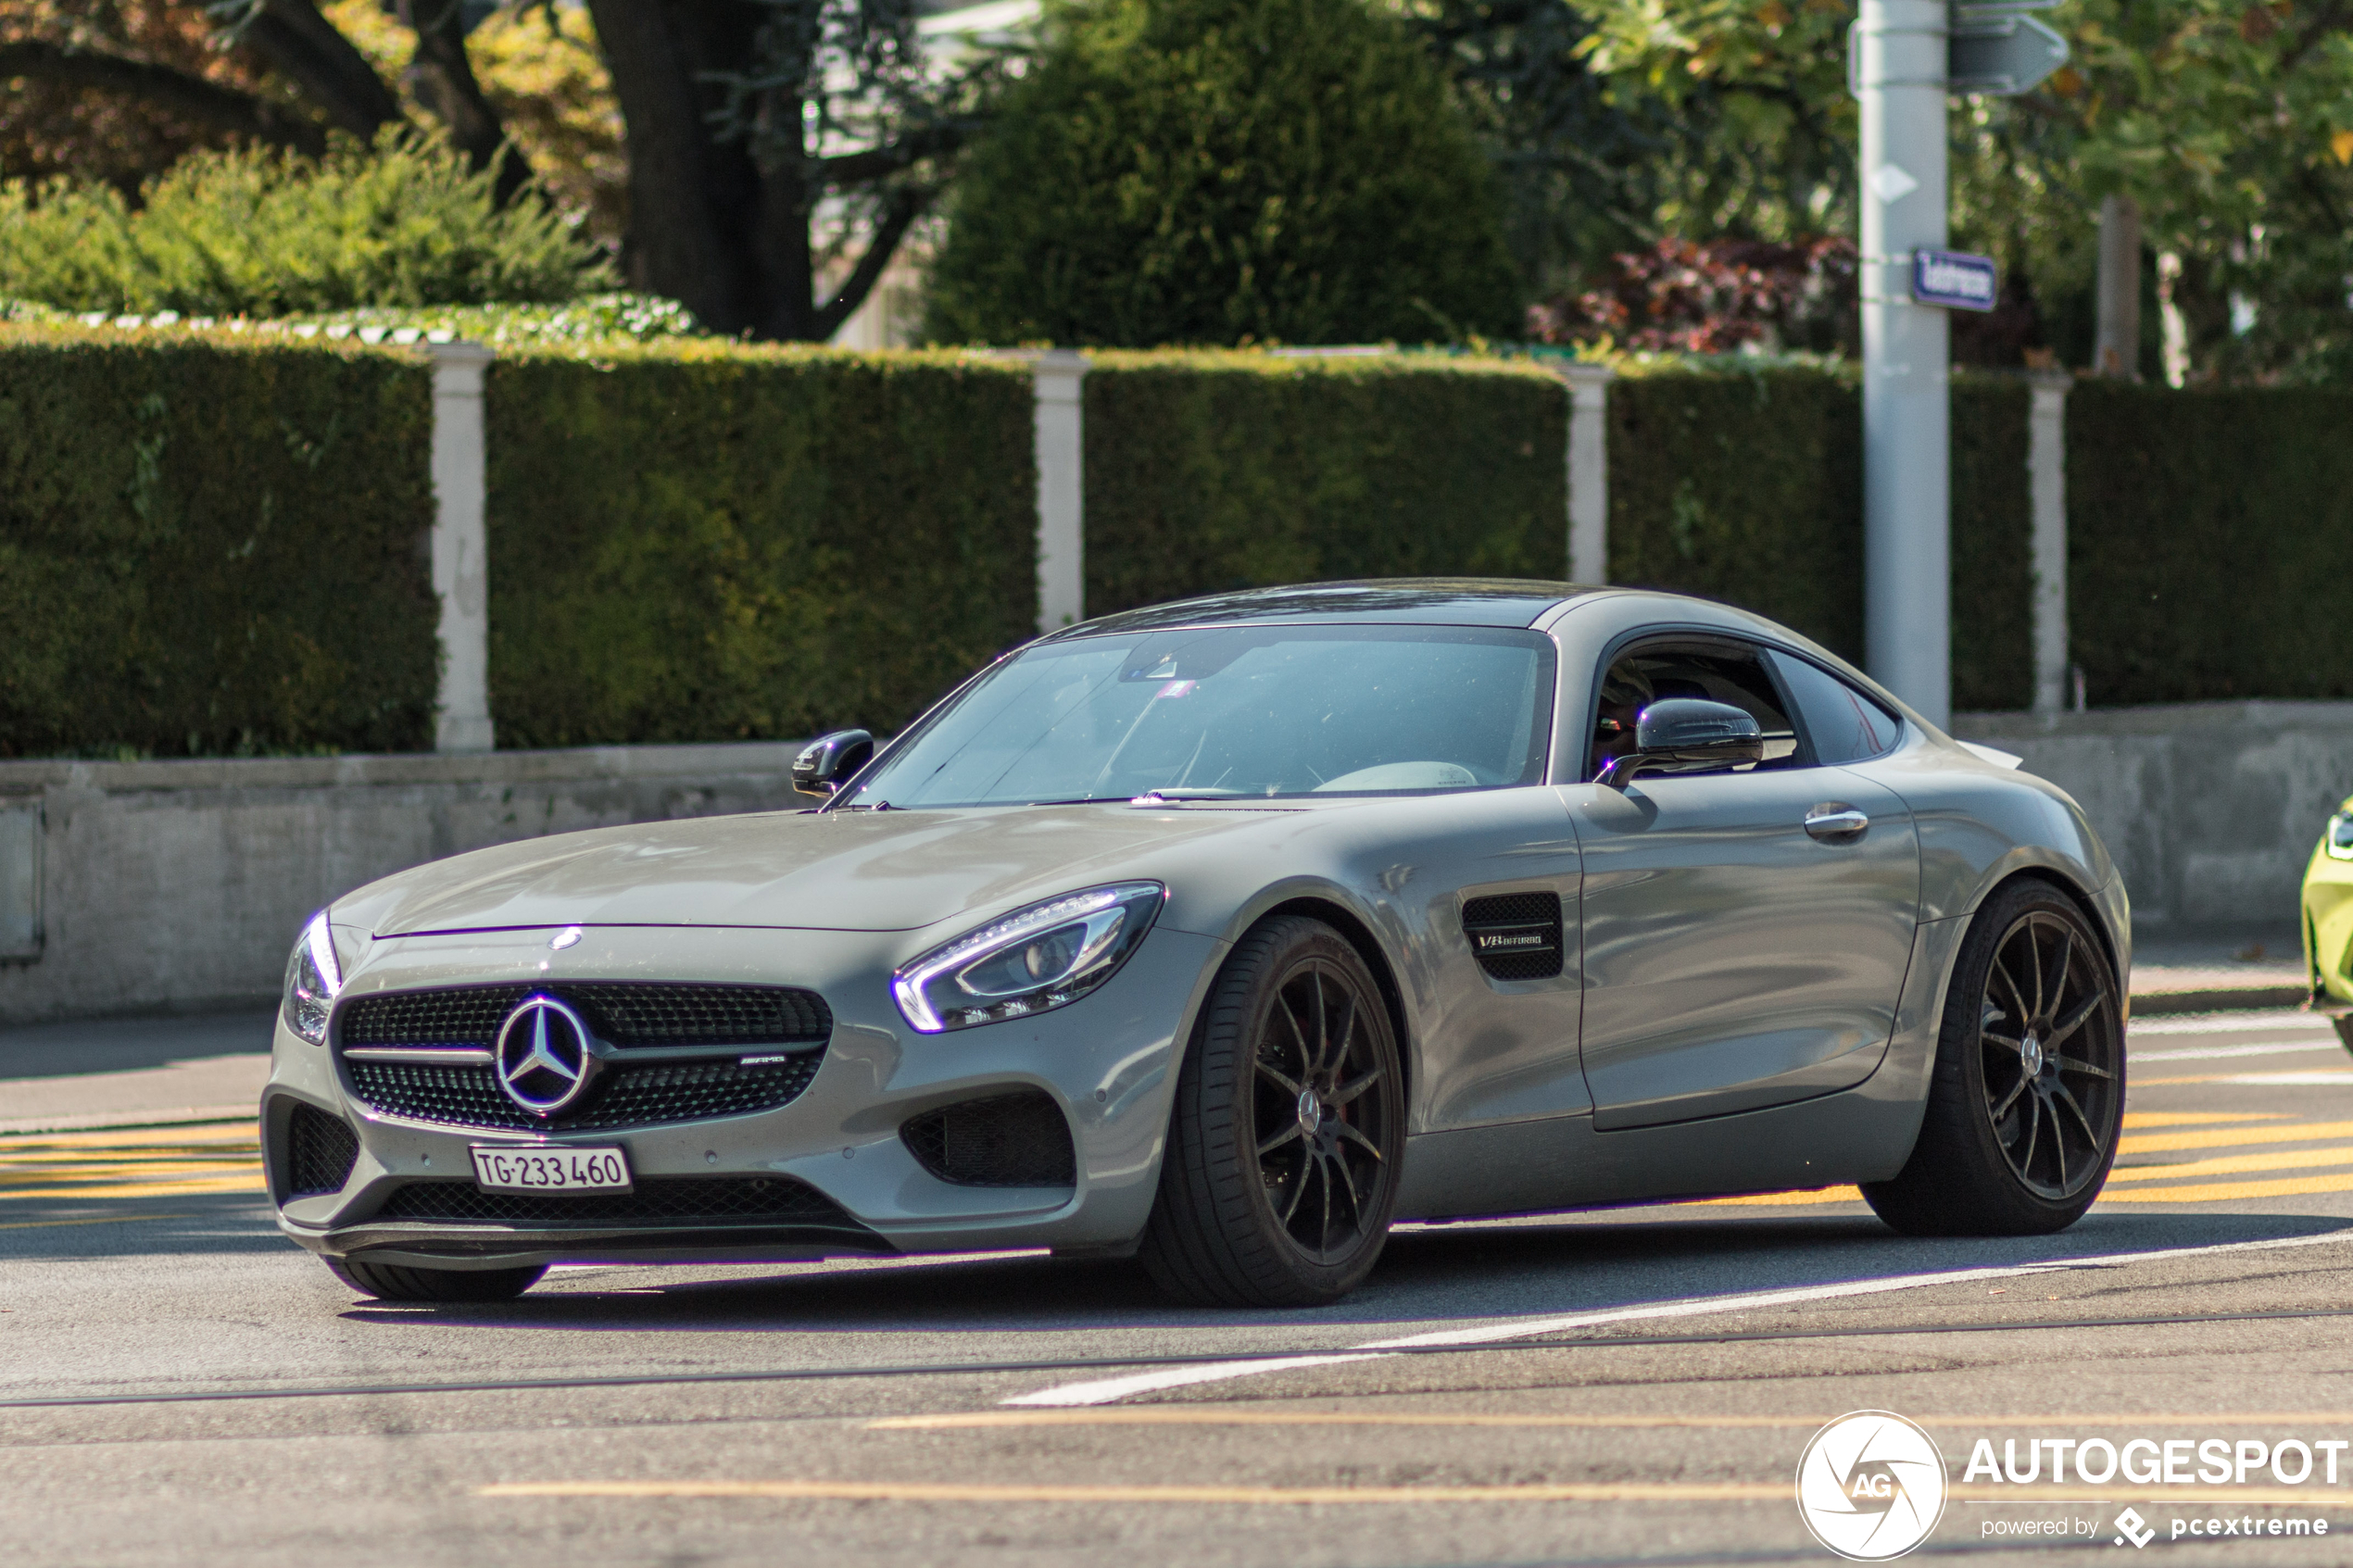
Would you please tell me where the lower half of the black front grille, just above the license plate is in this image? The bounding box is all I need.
[344,1051,826,1131]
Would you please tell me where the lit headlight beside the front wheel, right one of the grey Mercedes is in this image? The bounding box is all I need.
[892,882,1167,1035]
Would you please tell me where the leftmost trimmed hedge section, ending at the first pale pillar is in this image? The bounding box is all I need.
[0,327,435,757]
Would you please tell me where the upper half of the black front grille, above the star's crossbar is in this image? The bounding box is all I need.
[336,980,833,1048]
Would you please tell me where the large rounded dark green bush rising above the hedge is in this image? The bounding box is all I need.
[929,0,1517,348]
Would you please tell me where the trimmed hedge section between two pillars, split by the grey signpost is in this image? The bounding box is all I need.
[1609,367,2033,710]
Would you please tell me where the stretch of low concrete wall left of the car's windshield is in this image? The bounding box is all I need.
[0,746,807,1022]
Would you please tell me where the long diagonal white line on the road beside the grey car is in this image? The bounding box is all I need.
[1000,1229,2353,1406]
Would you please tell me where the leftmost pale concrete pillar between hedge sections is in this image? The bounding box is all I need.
[428,344,492,752]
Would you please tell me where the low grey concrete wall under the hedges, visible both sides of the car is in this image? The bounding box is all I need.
[0,703,2353,1025]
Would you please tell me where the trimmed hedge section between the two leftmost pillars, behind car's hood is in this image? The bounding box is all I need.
[484,341,1038,746]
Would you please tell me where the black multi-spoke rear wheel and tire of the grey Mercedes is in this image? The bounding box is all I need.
[1864,882,2125,1236]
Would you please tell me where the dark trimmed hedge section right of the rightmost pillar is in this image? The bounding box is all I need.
[2066,381,2353,705]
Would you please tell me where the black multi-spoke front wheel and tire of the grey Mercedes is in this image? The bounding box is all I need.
[1139,914,1404,1307]
